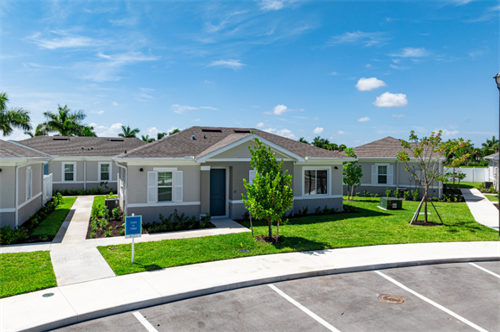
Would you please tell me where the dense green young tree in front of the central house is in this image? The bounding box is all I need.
[241,138,293,241]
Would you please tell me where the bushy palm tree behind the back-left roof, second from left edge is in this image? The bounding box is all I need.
[43,105,87,136]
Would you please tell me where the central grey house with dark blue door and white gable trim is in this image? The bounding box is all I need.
[114,127,353,221]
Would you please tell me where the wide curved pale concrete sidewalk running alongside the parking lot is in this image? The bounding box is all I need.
[0,242,500,331]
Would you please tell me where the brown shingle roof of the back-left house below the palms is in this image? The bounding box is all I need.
[19,136,149,157]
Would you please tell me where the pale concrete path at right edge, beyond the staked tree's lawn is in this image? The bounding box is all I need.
[460,189,498,230]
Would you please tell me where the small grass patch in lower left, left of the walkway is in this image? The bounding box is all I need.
[0,251,57,298]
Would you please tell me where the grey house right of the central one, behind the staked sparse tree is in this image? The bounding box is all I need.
[350,136,445,197]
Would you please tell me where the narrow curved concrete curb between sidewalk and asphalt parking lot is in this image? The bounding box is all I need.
[28,257,500,331]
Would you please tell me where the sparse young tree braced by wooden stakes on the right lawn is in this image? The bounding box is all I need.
[398,130,469,224]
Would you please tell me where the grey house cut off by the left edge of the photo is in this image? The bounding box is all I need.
[0,140,52,228]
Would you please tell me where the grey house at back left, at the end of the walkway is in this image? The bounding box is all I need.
[19,136,148,192]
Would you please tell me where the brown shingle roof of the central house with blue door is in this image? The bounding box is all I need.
[117,127,346,158]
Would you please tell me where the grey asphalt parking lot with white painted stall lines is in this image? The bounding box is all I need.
[57,261,500,332]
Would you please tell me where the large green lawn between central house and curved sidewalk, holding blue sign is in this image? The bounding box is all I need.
[98,197,499,275]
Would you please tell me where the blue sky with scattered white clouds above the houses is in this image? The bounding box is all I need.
[0,0,500,146]
